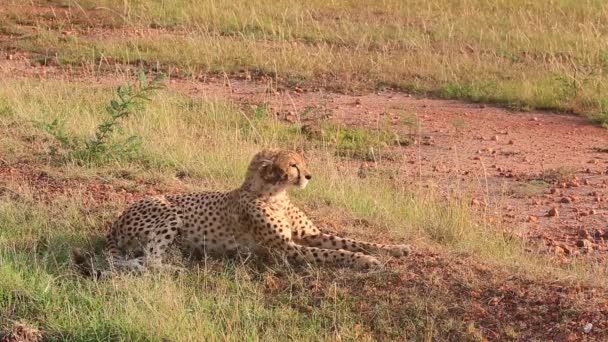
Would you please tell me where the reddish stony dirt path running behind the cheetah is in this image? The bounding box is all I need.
[0,53,608,258]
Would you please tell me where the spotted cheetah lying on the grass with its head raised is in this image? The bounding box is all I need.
[100,149,410,271]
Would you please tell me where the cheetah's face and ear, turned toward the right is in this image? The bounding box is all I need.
[259,150,312,189]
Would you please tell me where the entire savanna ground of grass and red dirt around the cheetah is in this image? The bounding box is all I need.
[0,0,608,341]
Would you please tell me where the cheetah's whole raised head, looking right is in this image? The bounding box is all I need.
[248,149,312,190]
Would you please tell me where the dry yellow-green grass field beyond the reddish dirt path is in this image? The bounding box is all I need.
[0,0,608,122]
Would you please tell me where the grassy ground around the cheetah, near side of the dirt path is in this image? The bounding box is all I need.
[0,79,605,341]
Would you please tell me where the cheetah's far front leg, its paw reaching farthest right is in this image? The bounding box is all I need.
[288,205,411,257]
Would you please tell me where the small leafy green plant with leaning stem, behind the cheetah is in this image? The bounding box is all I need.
[36,72,165,163]
